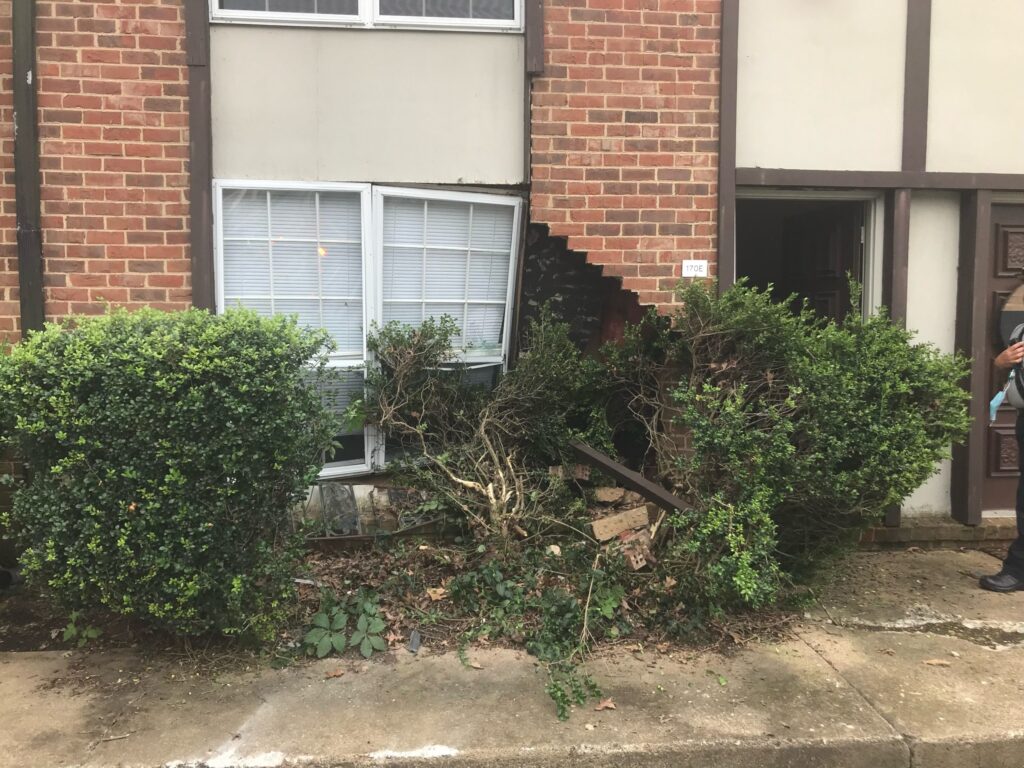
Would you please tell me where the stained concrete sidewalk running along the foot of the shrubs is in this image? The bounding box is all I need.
[0,551,1024,768]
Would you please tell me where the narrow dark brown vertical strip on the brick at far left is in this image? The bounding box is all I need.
[11,0,44,335]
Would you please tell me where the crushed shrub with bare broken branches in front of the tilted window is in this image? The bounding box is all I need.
[350,310,610,540]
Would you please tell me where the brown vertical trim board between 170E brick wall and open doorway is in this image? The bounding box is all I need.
[718,0,739,291]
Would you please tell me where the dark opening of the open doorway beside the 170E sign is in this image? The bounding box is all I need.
[736,199,864,319]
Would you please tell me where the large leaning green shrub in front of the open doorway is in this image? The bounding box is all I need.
[606,284,969,612]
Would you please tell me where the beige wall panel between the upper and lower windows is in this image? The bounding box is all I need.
[211,25,524,184]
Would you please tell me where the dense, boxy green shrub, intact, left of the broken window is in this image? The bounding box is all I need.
[0,310,334,636]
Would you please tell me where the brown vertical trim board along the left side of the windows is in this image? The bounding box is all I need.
[184,0,216,311]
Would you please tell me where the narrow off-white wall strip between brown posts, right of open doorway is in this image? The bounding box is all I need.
[903,190,959,515]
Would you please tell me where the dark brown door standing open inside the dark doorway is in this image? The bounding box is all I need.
[778,203,864,321]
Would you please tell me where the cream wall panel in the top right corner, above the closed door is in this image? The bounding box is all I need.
[928,0,1024,173]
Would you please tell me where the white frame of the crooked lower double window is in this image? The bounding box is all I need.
[213,179,522,480]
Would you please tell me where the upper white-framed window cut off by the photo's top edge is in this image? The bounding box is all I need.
[210,0,522,32]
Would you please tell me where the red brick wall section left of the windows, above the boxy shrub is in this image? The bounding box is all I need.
[33,0,191,323]
